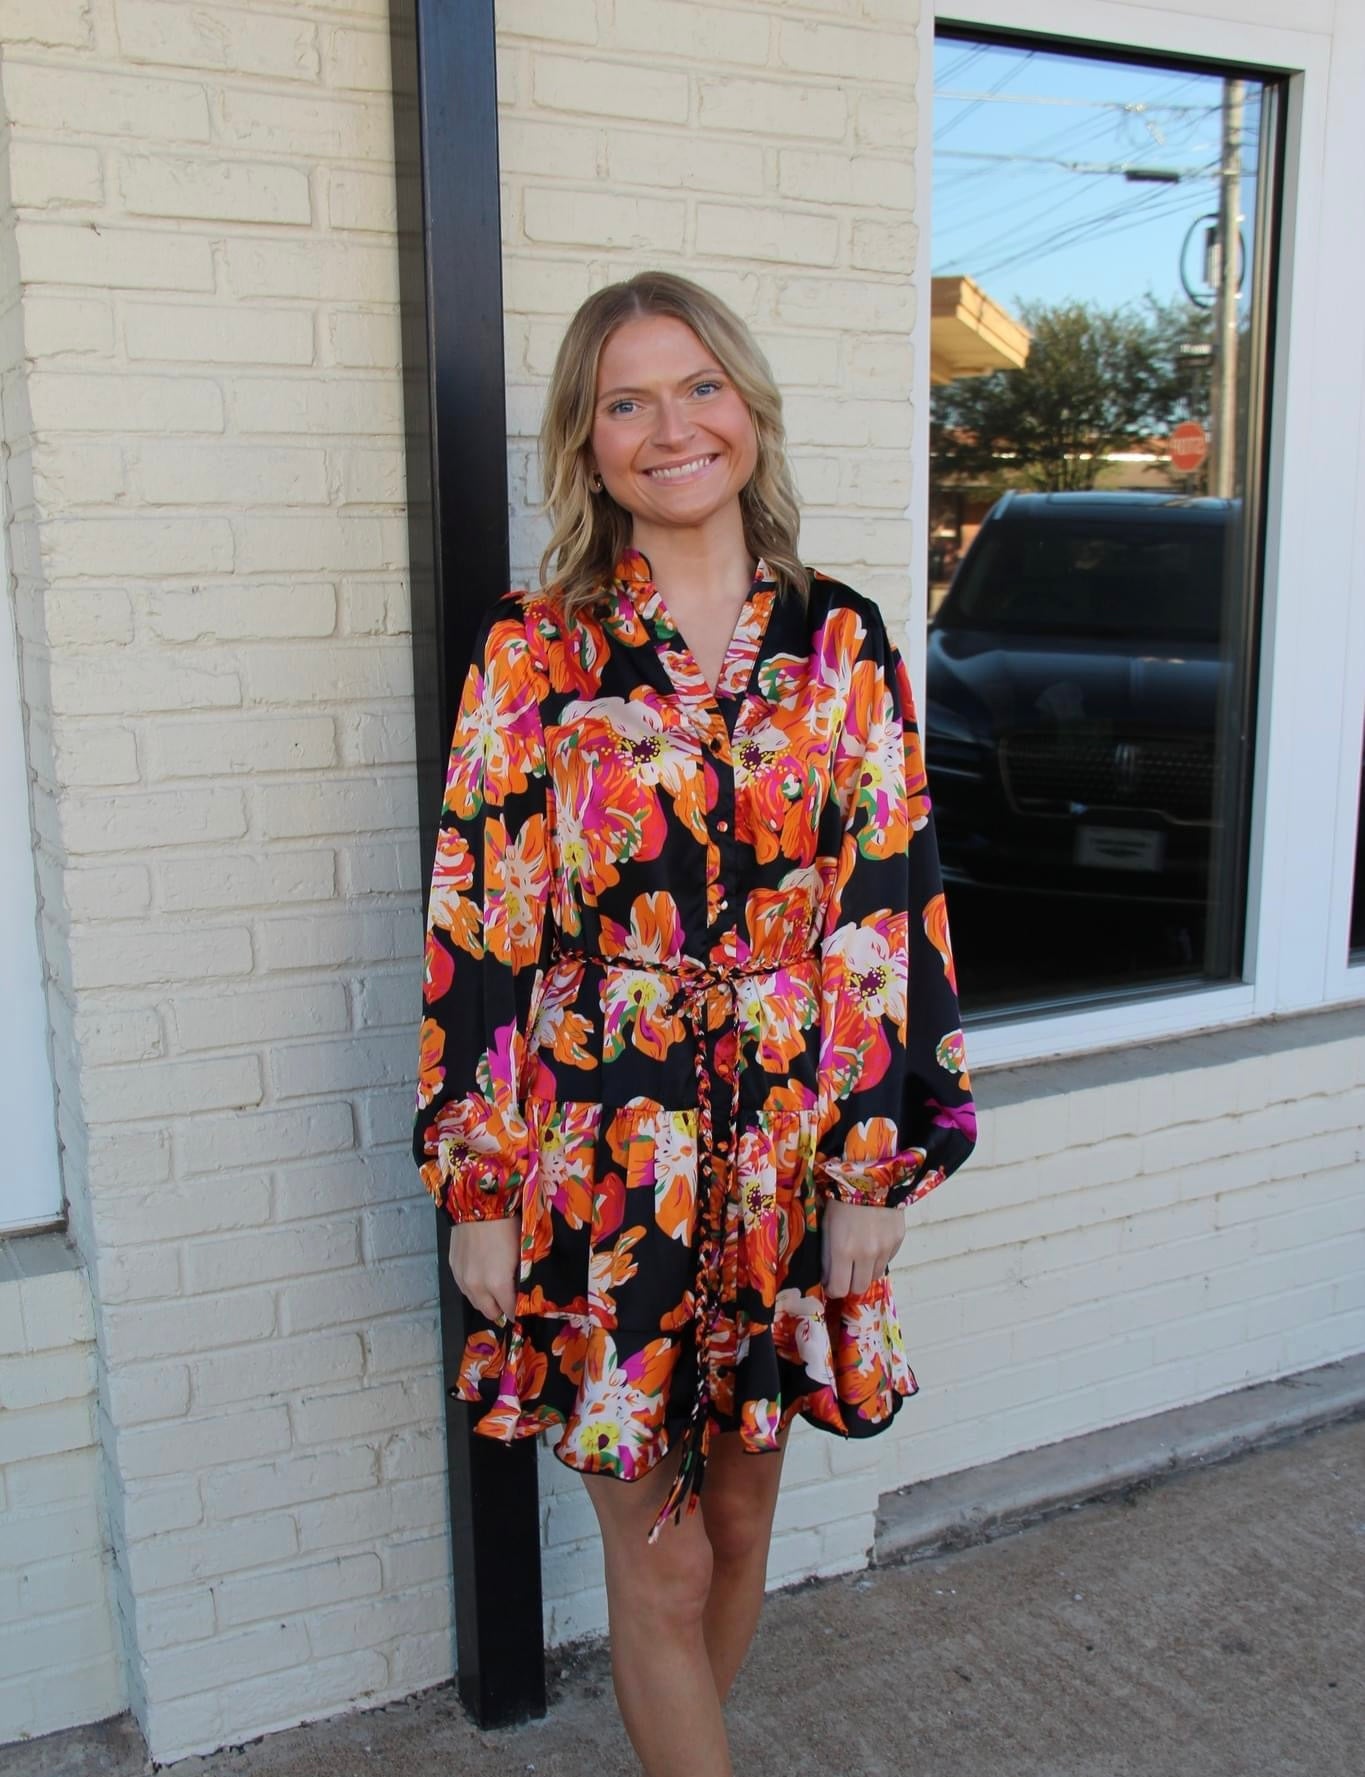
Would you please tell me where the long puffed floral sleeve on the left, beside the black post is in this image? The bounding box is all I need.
[412,599,549,1223]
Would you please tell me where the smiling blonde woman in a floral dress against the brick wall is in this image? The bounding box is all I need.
[414,272,976,1777]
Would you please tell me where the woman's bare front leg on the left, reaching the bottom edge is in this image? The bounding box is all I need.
[583,1445,732,1777]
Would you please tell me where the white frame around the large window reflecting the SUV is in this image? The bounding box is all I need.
[910,0,1365,1066]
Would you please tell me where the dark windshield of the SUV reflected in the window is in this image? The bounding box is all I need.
[935,522,1225,645]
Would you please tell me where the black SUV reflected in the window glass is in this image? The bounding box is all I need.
[924,494,1239,903]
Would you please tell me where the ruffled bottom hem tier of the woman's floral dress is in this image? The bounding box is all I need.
[450,1278,919,1480]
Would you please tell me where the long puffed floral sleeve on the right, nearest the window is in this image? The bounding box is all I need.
[816,620,976,1207]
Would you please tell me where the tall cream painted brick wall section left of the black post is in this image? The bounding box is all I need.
[0,0,437,1759]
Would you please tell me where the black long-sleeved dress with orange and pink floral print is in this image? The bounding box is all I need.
[414,549,976,1534]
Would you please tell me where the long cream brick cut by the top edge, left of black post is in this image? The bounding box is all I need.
[116,0,322,80]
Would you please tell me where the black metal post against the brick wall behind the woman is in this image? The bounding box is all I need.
[389,0,546,1727]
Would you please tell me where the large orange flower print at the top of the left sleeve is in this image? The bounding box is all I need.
[444,618,544,821]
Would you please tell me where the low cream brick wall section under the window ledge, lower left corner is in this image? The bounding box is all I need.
[0,1235,124,1745]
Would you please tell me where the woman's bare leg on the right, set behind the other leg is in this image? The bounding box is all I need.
[702,1432,787,1702]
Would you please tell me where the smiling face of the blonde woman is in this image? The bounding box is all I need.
[590,315,759,538]
